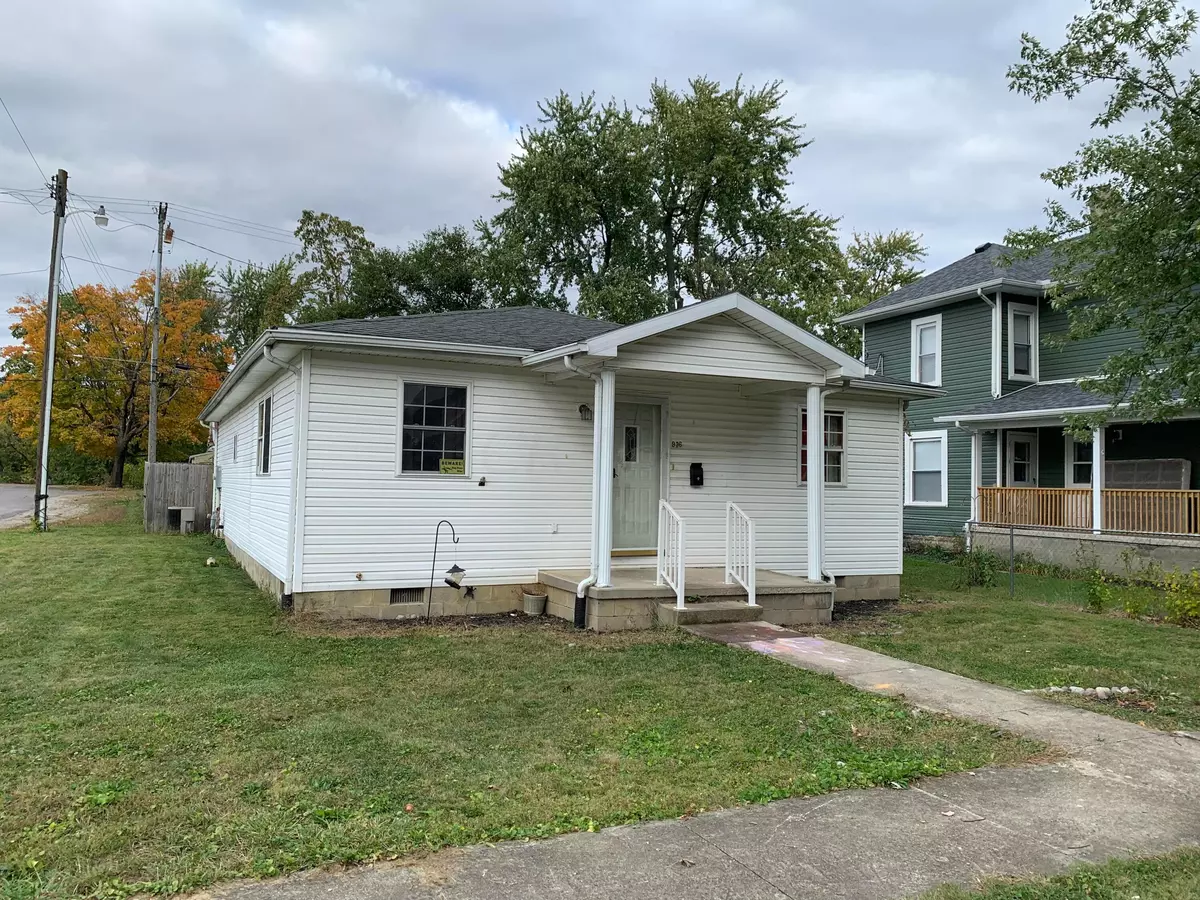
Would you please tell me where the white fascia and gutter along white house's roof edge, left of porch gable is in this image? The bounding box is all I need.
[200,328,529,422]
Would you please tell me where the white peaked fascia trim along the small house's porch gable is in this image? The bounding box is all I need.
[542,294,866,378]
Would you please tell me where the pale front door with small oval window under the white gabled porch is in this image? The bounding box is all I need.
[612,403,662,551]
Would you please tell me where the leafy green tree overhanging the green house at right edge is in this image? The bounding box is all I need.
[1008,0,1200,426]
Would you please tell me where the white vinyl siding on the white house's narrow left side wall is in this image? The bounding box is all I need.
[216,372,296,581]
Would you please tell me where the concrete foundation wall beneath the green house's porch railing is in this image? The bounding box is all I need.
[972,526,1200,575]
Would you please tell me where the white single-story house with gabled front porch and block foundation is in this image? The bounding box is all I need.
[203,294,940,629]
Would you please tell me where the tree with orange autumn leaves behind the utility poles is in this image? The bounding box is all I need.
[0,264,230,487]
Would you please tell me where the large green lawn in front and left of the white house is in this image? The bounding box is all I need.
[0,515,1040,899]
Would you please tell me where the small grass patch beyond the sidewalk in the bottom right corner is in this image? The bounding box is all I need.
[924,850,1200,900]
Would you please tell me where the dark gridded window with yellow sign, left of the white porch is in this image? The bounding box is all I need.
[400,382,467,475]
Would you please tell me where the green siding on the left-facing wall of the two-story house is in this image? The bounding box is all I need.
[865,298,996,534]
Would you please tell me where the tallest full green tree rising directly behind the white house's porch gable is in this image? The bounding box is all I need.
[487,78,845,326]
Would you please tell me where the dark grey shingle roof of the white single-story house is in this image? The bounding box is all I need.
[299,306,620,352]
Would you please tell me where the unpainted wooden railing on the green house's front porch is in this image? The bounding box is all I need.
[978,487,1200,534]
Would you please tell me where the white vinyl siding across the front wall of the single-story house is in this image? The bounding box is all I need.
[295,348,902,592]
